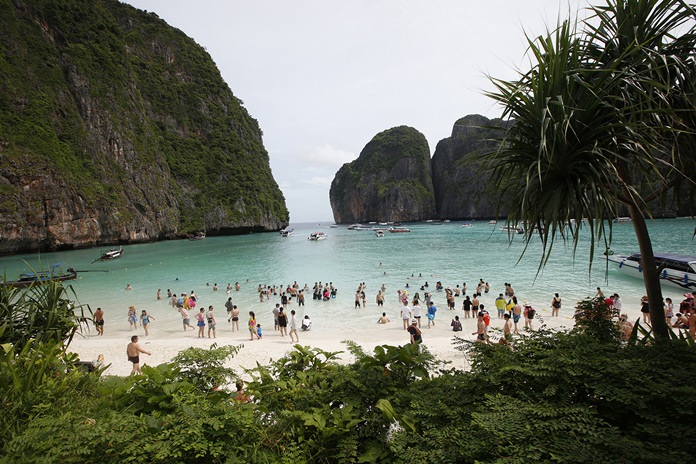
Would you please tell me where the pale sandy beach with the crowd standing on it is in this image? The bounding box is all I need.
[69,292,592,377]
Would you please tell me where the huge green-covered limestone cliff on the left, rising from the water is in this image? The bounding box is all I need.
[0,0,288,254]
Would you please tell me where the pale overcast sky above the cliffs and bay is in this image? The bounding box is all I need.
[125,0,597,223]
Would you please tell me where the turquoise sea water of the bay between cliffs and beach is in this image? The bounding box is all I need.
[0,218,696,331]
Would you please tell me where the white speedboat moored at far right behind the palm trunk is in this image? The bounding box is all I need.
[606,253,696,290]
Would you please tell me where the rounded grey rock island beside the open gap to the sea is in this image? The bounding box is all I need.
[329,126,435,223]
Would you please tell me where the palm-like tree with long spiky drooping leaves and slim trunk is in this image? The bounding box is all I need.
[488,0,696,340]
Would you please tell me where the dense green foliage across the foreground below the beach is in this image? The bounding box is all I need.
[0,280,696,463]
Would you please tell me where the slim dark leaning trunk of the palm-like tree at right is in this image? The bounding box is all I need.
[629,205,669,343]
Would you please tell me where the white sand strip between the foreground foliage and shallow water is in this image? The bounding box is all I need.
[70,305,573,376]
